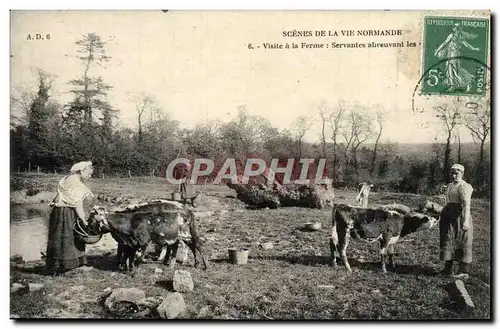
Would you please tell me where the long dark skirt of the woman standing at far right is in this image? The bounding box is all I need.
[439,203,473,263]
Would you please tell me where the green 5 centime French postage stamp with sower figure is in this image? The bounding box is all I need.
[421,16,490,95]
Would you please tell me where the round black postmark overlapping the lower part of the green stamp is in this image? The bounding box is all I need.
[411,56,491,129]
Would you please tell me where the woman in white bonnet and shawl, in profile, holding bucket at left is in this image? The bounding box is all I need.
[46,161,94,274]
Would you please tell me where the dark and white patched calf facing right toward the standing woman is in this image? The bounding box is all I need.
[330,204,437,273]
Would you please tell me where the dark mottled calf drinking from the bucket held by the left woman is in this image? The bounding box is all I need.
[89,200,207,269]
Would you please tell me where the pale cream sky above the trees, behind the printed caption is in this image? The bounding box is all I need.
[10,10,487,143]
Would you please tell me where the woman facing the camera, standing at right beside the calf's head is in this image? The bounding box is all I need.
[439,164,473,278]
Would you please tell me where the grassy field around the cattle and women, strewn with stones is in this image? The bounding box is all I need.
[10,175,491,320]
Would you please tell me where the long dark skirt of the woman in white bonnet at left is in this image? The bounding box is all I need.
[46,207,87,274]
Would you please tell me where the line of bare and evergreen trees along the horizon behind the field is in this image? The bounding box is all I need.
[10,33,490,195]
